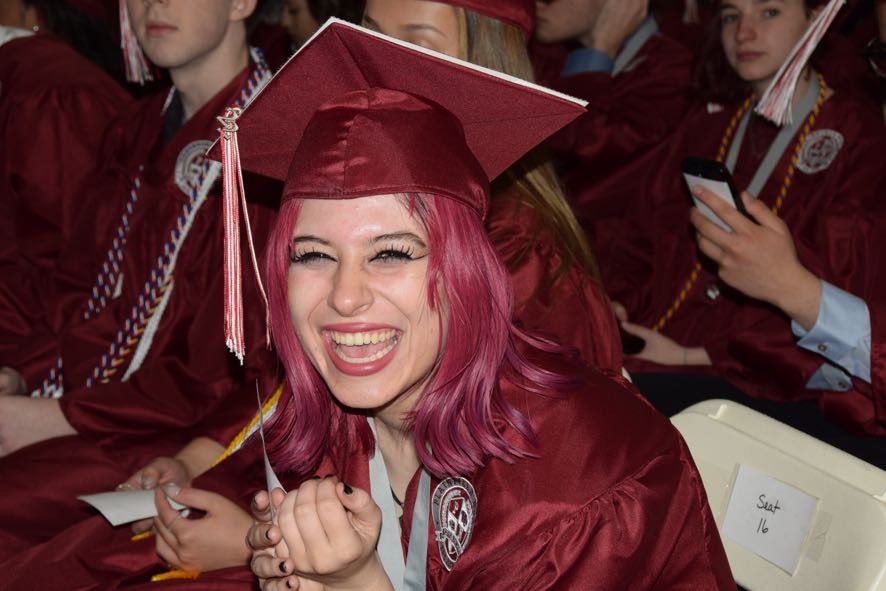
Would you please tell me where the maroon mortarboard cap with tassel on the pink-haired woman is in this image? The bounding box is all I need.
[210,20,584,360]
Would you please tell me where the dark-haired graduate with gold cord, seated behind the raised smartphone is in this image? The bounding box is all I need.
[599,0,886,455]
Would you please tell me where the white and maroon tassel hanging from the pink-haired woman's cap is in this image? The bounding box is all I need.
[218,108,271,364]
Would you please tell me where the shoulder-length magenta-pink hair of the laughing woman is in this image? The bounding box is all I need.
[267,195,576,477]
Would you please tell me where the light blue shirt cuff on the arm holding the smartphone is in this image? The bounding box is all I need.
[791,281,871,390]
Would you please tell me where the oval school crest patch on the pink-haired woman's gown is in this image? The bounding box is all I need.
[431,478,477,571]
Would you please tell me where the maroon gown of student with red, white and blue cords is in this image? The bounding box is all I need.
[0,71,279,554]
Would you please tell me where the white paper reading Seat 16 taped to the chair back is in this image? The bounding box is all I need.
[722,466,818,575]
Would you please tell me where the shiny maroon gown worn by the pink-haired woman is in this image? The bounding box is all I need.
[382,372,735,590]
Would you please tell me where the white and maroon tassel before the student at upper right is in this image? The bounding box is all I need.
[754,0,846,126]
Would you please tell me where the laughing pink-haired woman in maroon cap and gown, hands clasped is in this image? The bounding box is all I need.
[237,20,734,589]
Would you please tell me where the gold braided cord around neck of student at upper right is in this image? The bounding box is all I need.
[654,74,830,331]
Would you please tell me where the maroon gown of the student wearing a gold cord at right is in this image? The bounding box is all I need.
[599,82,886,434]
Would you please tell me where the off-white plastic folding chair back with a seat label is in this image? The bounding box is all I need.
[671,400,886,591]
